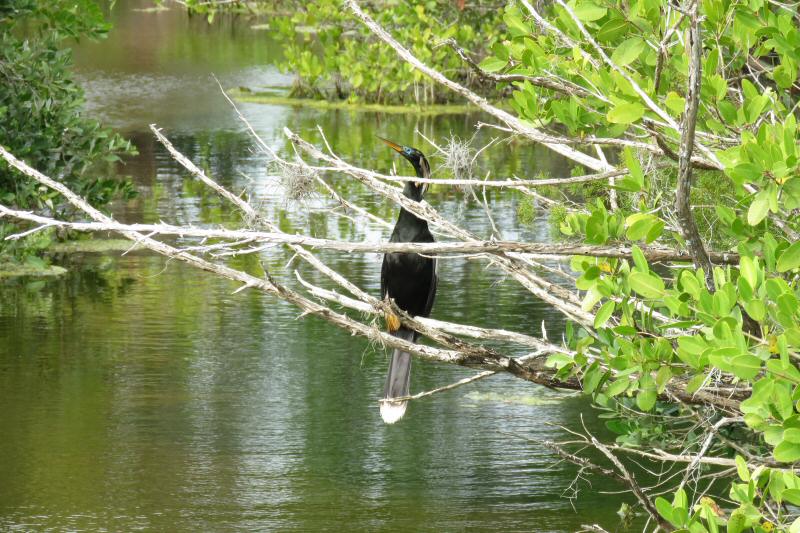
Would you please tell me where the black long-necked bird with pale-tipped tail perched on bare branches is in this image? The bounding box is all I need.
[381,138,436,424]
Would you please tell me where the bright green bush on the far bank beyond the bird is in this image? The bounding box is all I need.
[271,0,504,105]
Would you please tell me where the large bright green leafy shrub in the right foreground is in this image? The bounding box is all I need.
[468,0,800,532]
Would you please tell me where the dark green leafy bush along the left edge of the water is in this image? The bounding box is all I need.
[0,0,134,262]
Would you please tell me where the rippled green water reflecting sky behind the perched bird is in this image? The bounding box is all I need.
[0,1,633,531]
